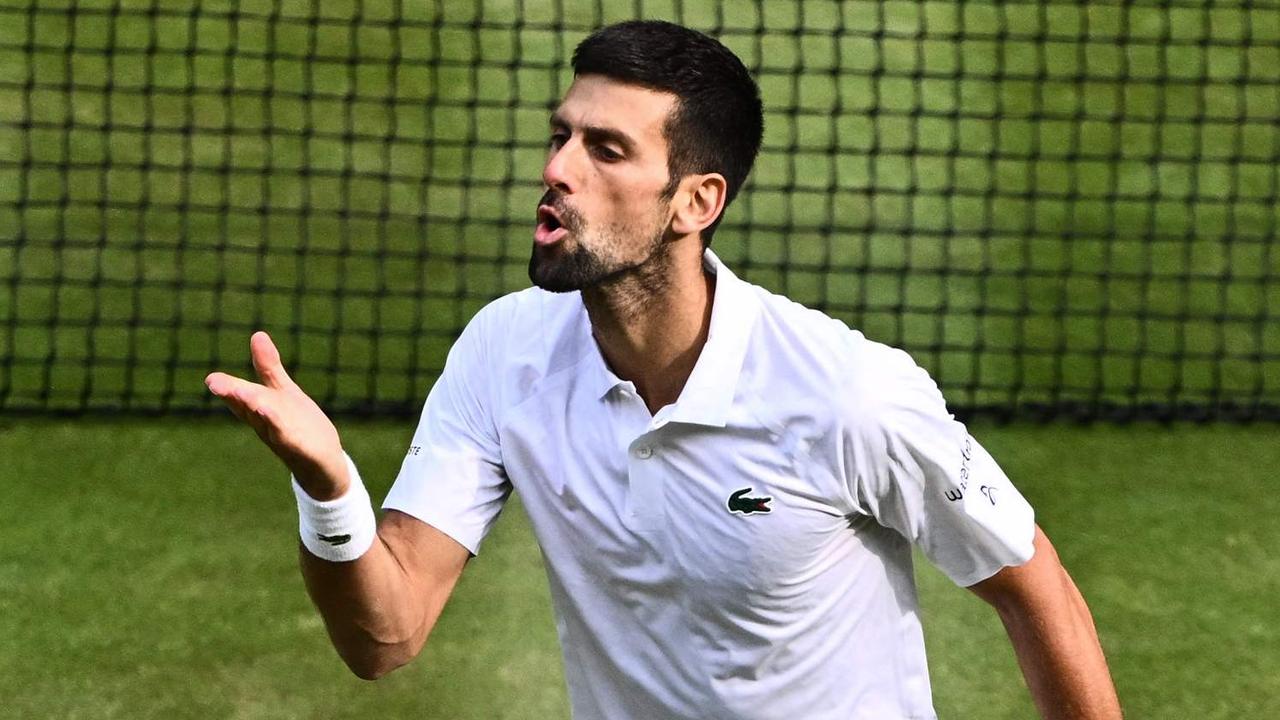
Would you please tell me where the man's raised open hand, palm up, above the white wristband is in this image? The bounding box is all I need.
[205,331,351,501]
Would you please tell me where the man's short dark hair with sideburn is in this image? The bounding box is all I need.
[572,20,764,243]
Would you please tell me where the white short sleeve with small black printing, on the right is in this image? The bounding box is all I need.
[845,343,1036,587]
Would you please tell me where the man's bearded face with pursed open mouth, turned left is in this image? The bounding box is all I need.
[529,76,676,292]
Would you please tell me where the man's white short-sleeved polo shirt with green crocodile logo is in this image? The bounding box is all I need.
[383,251,1034,720]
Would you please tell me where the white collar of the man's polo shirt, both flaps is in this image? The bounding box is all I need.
[581,249,760,428]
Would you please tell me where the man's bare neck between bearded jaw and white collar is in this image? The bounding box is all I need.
[582,242,716,414]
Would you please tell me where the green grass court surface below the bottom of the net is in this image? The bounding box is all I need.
[0,415,1280,720]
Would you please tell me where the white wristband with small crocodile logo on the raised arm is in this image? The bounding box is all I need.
[289,454,378,562]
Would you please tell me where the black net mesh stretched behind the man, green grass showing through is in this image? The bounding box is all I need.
[0,0,1280,418]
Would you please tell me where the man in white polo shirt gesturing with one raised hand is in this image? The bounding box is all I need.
[207,22,1120,720]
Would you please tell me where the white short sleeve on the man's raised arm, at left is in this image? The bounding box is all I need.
[383,304,511,555]
